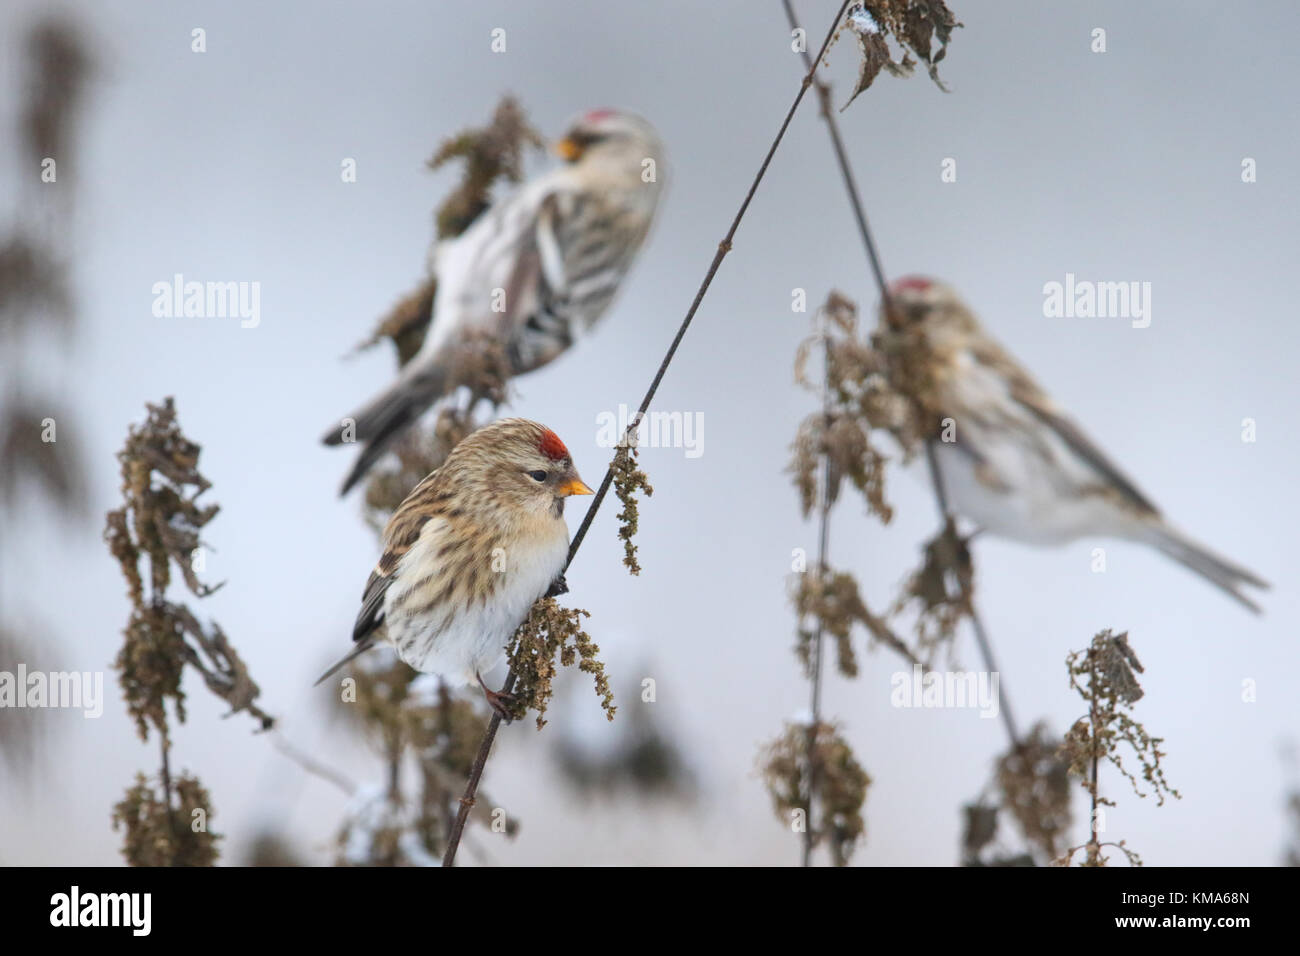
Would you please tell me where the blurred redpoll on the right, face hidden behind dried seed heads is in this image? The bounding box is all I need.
[880,276,1269,613]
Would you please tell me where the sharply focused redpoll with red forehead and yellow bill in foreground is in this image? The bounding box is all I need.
[316,419,592,715]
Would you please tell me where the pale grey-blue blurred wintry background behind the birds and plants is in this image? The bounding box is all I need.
[0,0,1300,865]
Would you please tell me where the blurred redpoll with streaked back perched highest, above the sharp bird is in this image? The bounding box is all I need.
[324,109,663,494]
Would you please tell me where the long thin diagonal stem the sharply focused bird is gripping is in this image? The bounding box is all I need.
[442,0,850,866]
